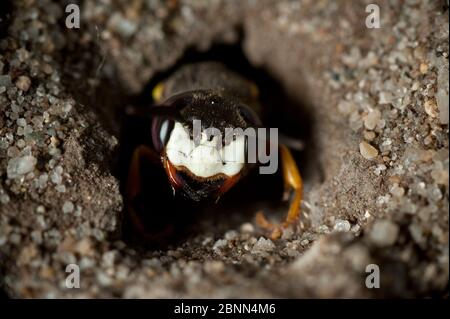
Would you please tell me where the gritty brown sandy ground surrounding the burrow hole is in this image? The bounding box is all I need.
[0,0,449,298]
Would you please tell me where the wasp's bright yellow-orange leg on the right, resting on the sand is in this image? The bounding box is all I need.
[256,145,303,239]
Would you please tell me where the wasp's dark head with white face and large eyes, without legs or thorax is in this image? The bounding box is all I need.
[152,90,260,200]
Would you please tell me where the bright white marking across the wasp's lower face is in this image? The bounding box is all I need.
[166,122,245,177]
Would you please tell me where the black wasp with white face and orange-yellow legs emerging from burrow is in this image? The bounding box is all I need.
[126,62,303,239]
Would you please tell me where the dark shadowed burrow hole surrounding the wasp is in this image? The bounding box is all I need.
[117,39,321,248]
